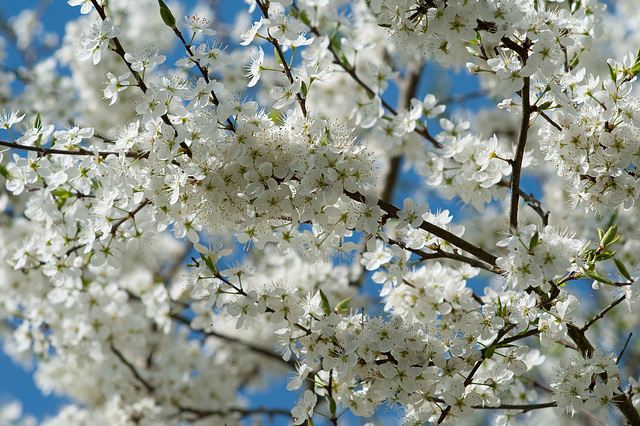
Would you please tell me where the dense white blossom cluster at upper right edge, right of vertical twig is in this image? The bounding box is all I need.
[540,54,640,214]
